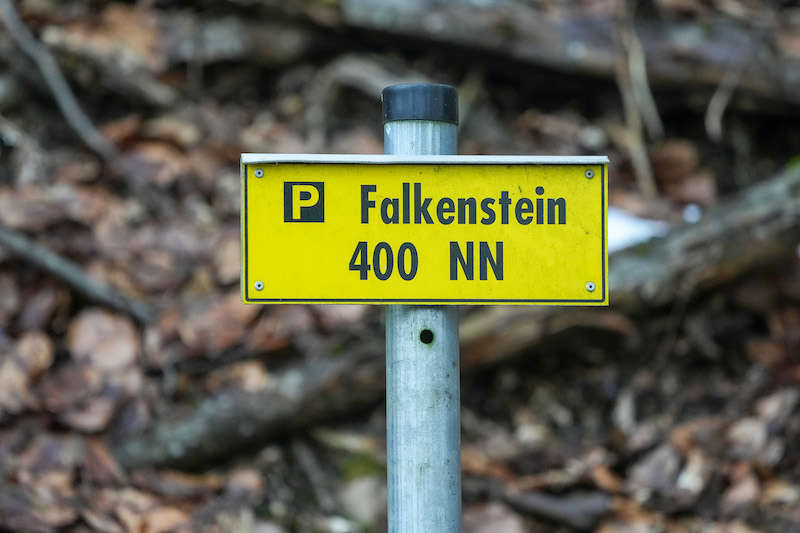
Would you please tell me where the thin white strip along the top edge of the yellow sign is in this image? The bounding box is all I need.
[242,154,609,165]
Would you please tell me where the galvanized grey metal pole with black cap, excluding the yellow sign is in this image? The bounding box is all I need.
[382,84,461,533]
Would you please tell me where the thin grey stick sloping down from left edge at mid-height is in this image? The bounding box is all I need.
[0,224,150,323]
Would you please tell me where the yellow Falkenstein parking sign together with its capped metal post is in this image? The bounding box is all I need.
[242,84,609,533]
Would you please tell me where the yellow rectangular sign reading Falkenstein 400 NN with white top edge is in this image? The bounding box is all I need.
[242,154,609,305]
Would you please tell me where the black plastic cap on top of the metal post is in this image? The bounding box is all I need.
[381,83,458,124]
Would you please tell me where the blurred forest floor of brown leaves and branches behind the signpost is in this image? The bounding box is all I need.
[0,0,800,533]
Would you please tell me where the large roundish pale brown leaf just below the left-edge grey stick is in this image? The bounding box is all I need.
[67,309,141,372]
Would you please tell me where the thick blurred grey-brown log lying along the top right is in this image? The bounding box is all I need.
[241,0,800,104]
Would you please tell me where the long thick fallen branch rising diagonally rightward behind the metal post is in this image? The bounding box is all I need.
[115,166,800,466]
